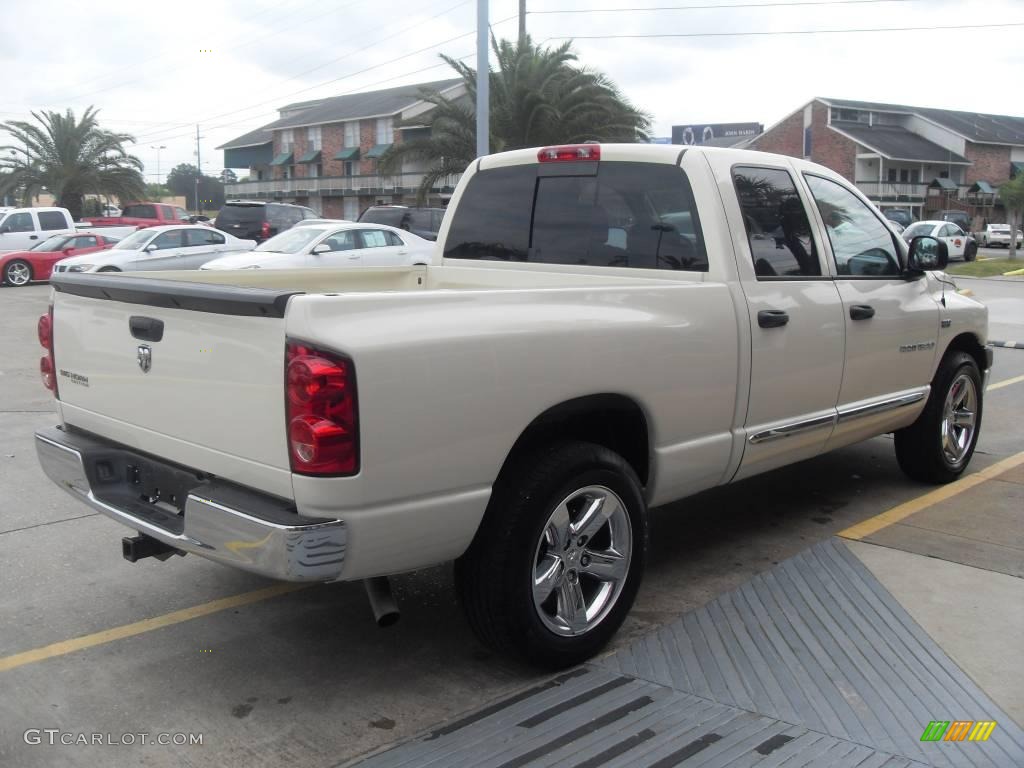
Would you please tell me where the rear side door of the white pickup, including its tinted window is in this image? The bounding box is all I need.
[709,156,844,478]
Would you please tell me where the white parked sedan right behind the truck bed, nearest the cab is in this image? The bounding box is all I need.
[202,221,435,269]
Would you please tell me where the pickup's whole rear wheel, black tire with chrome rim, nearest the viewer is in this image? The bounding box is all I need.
[456,442,647,669]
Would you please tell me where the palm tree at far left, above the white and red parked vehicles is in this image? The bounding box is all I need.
[0,106,145,219]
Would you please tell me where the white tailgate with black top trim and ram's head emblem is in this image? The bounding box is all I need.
[52,273,296,498]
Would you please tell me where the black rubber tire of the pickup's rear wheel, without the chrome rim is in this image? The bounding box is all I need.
[456,442,647,669]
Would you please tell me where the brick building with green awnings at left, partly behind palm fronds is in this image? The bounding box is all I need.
[217,79,465,219]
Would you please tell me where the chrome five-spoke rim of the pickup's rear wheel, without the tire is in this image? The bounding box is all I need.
[532,485,633,637]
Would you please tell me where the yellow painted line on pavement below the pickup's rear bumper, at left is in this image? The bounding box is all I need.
[0,583,311,672]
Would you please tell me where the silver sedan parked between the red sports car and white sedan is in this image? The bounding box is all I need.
[53,224,256,273]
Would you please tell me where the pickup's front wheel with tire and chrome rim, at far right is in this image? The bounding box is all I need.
[894,352,983,483]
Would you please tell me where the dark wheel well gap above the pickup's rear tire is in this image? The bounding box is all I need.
[499,394,650,485]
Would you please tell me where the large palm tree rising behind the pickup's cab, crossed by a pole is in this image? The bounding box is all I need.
[381,36,650,202]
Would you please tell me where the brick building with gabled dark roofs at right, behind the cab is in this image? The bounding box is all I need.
[748,98,1024,228]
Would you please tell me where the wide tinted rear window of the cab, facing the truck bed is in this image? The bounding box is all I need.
[444,162,708,271]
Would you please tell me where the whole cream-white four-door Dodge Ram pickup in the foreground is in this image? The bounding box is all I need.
[36,144,992,667]
